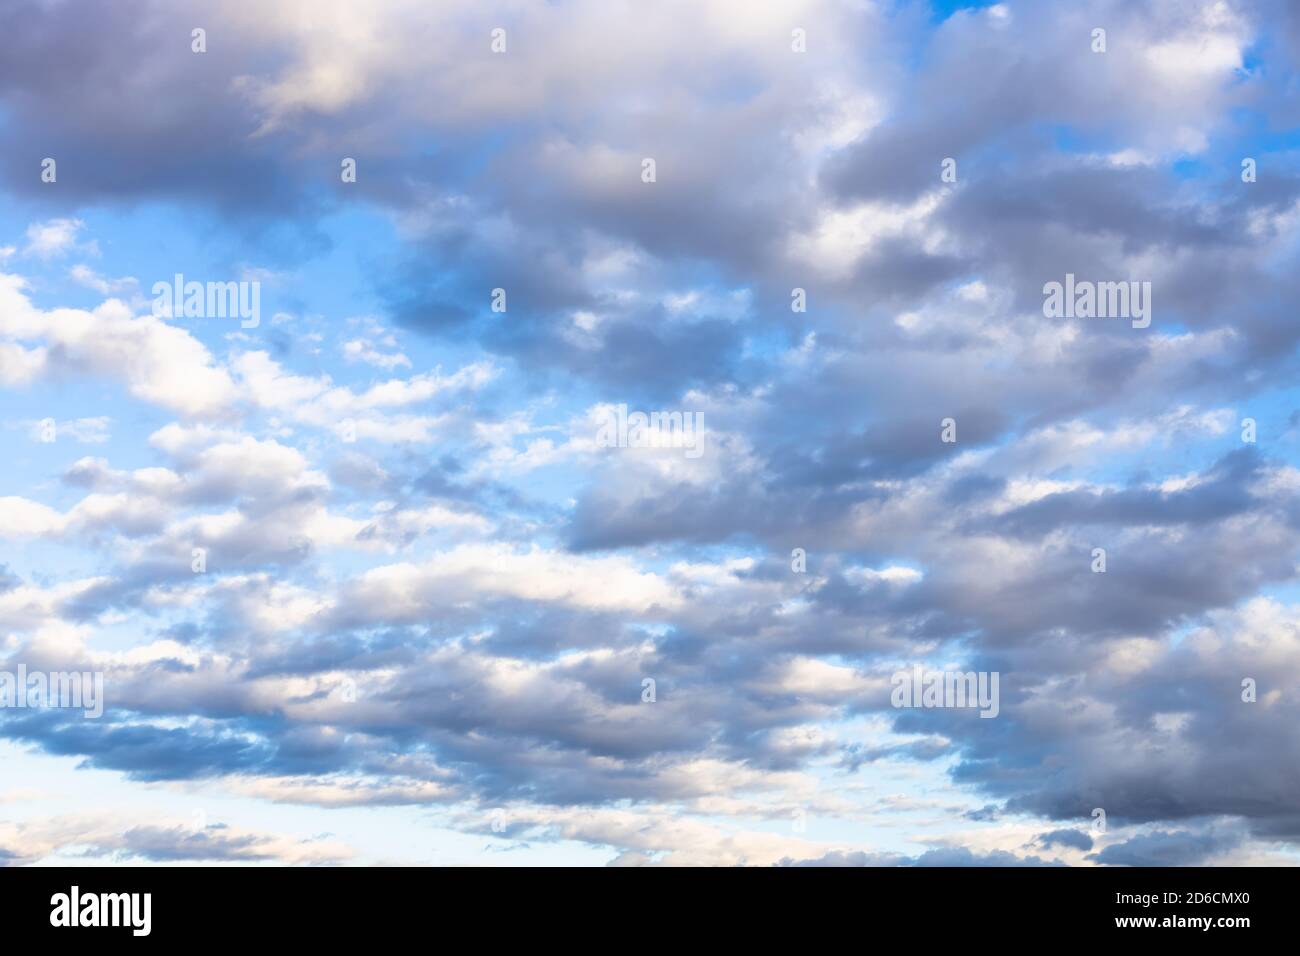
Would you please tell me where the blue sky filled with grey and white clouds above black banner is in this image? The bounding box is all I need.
[0,0,1300,866]
